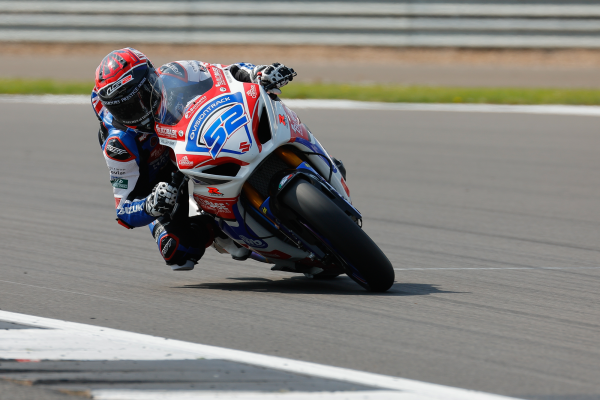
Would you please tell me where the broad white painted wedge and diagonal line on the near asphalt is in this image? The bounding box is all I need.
[0,311,520,400]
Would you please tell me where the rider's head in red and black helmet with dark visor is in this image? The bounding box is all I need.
[96,47,159,131]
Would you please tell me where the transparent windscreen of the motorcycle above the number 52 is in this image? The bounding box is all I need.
[153,61,213,125]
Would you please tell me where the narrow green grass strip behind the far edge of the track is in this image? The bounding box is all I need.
[0,79,600,105]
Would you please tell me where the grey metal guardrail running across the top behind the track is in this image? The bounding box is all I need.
[0,0,600,48]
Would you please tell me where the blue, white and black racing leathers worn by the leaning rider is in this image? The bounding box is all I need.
[91,62,254,270]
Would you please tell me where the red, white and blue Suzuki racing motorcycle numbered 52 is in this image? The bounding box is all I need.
[153,61,394,292]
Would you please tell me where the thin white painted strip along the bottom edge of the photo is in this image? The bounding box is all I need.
[91,389,426,400]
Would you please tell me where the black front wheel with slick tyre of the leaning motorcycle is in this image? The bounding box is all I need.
[280,179,394,292]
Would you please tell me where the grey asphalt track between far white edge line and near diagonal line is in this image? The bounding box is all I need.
[0,104,600,400]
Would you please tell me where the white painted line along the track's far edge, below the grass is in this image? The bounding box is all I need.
[0,94,600,117]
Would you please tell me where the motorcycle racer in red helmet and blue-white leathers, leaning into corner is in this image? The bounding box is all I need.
[91,48,295,271]
